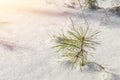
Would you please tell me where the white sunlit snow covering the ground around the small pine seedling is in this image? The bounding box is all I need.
[0,0,120,80]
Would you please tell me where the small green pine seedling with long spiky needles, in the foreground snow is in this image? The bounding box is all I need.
[53,22,100,68]
